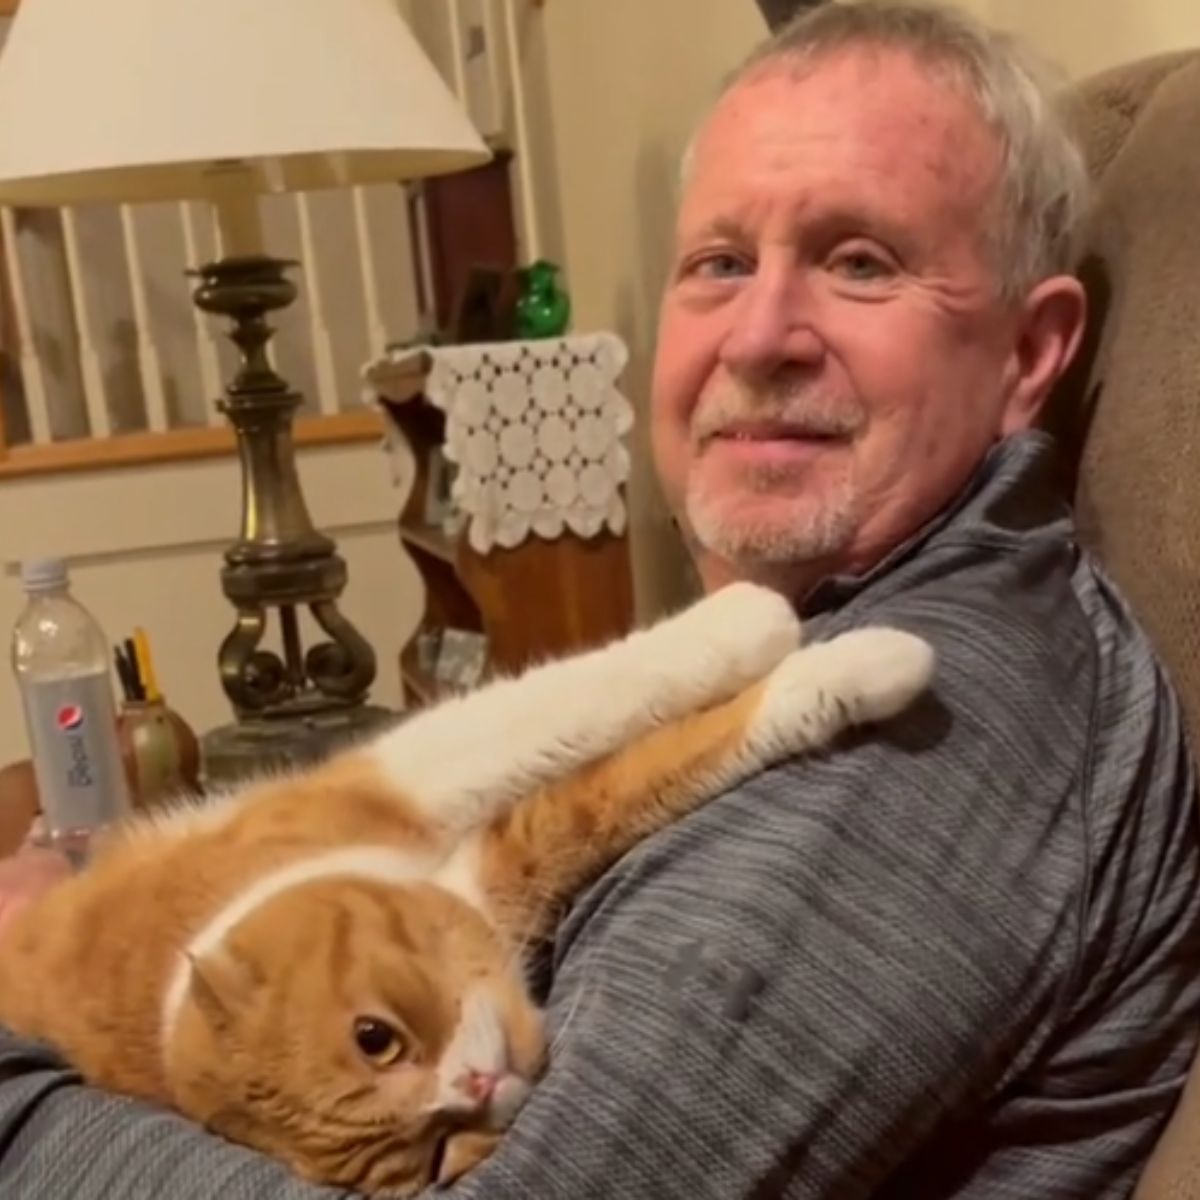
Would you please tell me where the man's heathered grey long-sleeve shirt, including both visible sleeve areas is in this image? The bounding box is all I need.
[0,434,1200,1200]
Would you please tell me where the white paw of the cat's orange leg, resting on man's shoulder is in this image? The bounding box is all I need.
[751,628,935,751]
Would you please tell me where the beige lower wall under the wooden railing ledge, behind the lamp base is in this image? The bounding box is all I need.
[0,445,420,764]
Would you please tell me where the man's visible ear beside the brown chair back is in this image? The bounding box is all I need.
[1002,275,1087,434]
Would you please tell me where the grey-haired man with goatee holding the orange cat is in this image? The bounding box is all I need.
[0,4,1200,1200]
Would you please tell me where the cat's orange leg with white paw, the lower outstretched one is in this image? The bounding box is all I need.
[472,629,934,941]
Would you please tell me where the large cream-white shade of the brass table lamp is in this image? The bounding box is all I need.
[0,0,490,204]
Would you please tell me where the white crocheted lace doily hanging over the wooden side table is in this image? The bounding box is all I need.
[360,332,634,554]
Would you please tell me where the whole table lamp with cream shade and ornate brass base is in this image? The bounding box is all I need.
[0,0,490,781]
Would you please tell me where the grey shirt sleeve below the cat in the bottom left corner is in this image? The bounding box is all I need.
[0,1033,347,1200]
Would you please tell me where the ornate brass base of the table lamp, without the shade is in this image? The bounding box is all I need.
[190,256,397,785]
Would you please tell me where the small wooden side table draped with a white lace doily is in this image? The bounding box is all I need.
[364,332,634,707]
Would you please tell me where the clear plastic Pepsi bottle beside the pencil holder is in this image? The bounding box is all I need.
[12,558,131,859]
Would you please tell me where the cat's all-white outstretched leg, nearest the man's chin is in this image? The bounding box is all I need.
[368,583,800,833]
